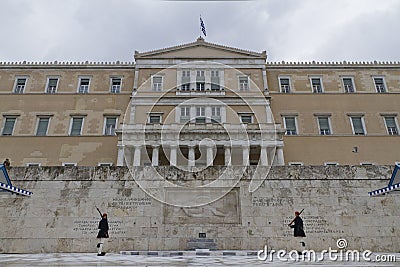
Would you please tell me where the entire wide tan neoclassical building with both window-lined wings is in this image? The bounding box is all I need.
[0,38,400,168]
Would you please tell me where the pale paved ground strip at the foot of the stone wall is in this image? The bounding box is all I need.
[0,253,400,267]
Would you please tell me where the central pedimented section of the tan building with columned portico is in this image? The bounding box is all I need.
[118,38,284,170]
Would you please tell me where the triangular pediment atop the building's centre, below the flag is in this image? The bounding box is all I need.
[135,38,266,60]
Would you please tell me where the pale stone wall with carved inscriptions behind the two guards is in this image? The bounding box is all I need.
[0,166,400,253]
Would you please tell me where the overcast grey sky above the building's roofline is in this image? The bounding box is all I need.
[0,0,400,61]
